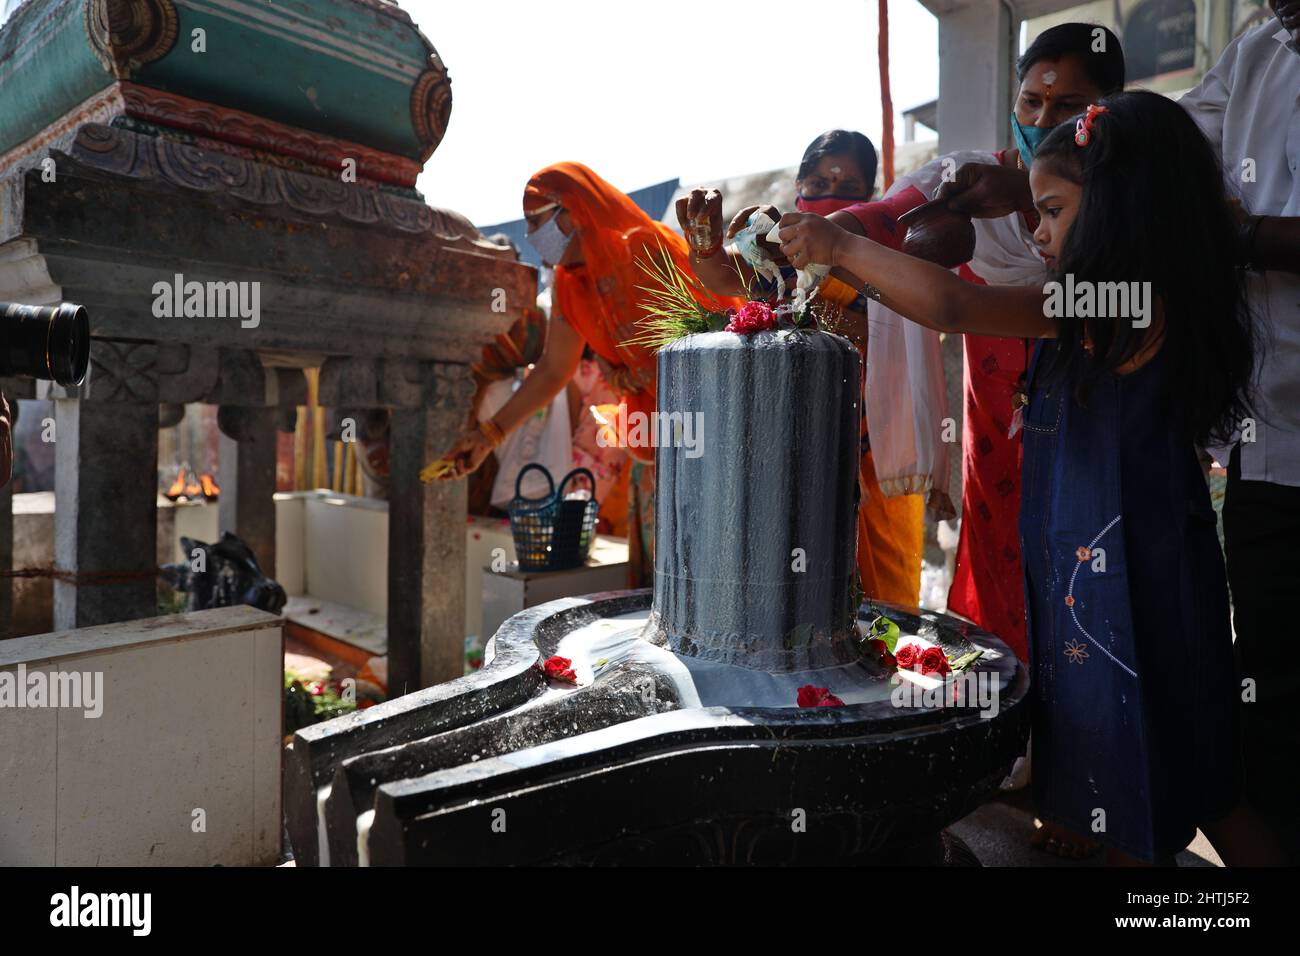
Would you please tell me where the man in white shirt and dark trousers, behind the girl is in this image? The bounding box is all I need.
[1180,0,1300,862]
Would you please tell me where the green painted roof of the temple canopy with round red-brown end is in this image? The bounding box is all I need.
[0,0,451,167]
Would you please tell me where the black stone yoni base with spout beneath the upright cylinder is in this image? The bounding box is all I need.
[286,591,1028,865]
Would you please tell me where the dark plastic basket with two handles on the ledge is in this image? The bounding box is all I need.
[506,462,598,571]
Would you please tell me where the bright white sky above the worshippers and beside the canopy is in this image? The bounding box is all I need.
[400,0,939,225]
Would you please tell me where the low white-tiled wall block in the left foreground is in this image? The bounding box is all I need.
[0,606,283,866]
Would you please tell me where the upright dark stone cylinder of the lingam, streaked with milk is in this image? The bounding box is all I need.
[647,330,861,671]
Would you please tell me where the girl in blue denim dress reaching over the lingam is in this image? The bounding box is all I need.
[780,92,1288,864]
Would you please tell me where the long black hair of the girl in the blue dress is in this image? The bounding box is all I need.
[1034,91,1256,446]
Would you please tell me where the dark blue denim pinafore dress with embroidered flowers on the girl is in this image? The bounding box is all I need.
[1021,339,1242,862]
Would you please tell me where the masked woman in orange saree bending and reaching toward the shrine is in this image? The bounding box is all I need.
[450,163,731,587]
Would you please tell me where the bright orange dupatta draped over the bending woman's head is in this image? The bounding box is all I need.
[524,163,735,460]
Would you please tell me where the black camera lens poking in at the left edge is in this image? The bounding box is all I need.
[0,302,90,385]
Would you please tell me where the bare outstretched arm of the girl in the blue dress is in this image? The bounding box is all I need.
[779,212,1056,338]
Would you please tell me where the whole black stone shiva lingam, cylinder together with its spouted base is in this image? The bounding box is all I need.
[286,329,1027,865]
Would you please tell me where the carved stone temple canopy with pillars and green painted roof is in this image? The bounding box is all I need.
[0,0,536,687]
